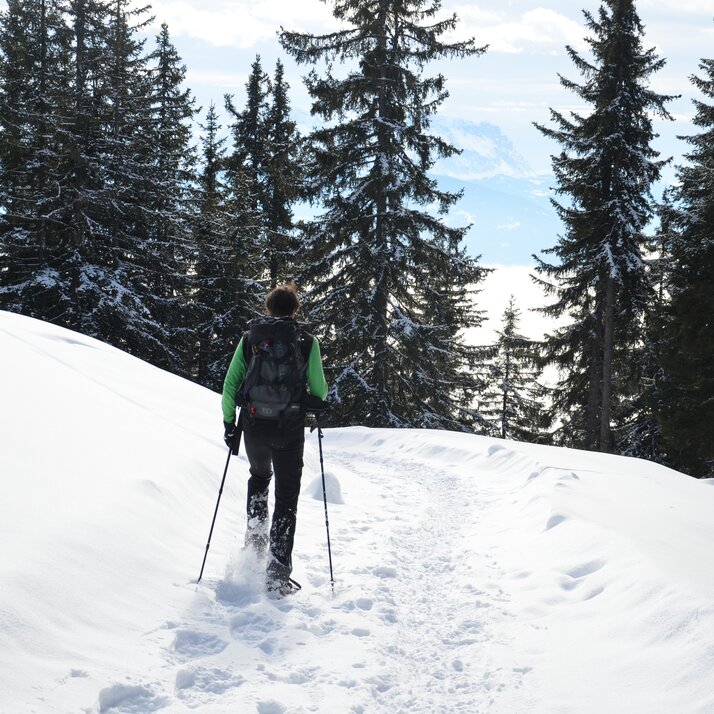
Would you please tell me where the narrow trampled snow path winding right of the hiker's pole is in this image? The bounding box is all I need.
[322,442,520,712]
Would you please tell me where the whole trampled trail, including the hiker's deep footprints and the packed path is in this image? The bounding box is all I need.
[112,432,529,714]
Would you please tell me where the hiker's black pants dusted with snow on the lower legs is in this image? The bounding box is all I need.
[243,416,305,581]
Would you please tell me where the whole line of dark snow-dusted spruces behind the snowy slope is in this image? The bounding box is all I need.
[0,0,714,476]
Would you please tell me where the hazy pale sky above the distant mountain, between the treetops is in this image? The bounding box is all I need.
[139,0,714,173]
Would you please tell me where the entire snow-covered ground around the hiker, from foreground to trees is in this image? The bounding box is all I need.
[0,313,714,714]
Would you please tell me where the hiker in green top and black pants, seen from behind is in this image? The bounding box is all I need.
[222,283,327,595]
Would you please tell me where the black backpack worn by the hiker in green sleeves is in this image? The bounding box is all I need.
[240,317,312,423]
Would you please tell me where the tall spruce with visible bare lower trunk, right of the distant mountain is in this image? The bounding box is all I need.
[536,0,671,451]
